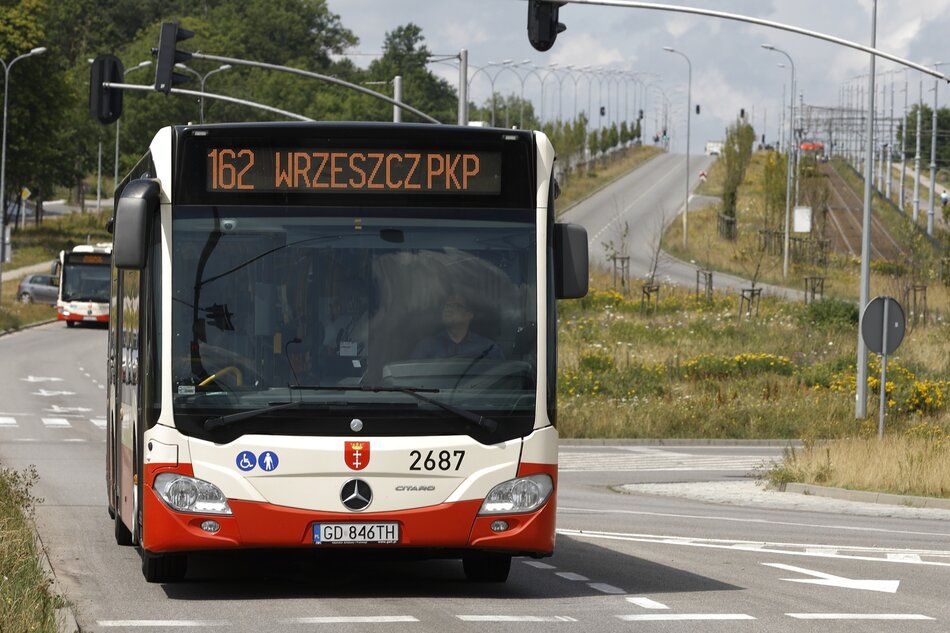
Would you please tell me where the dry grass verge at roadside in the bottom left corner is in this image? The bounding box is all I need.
[0,467,63,633]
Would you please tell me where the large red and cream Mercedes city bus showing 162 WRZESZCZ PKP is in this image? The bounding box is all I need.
[106,123,588,582]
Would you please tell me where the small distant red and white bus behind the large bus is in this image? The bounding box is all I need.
[53,243,112,327]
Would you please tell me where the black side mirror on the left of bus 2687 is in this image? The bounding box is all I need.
[112,180,159,270]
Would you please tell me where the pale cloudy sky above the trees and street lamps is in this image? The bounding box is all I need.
[327,0,950,152]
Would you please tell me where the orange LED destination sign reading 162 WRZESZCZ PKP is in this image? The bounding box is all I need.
[206,146,501,194]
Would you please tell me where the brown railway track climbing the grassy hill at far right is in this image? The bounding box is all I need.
[820,163,906,262]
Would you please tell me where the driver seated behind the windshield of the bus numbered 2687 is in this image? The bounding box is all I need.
[411,292,505,360]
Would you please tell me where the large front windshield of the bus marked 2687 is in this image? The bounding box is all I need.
[172,206,537,435]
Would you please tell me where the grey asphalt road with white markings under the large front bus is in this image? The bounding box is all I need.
[0,323,950,633]
